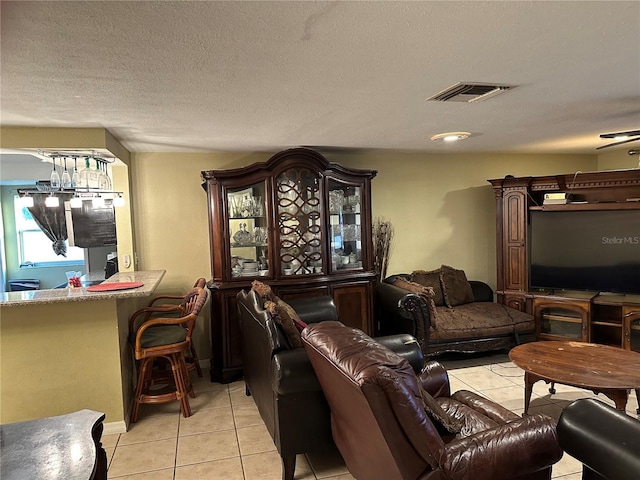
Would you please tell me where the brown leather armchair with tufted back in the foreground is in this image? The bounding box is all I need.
[302,322,562,480]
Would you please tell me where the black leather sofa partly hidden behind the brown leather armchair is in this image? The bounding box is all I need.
[237,290,424,480]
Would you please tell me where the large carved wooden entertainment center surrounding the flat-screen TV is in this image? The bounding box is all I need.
[489,169,640,351]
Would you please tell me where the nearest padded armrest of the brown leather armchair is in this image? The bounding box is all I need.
[438,414,562,480]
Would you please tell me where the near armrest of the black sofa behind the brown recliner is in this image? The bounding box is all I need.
[271,348,322,395]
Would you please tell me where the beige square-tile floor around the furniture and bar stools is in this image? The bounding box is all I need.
[102,353,638,480]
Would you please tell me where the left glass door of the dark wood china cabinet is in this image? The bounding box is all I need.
[227,182,269,278]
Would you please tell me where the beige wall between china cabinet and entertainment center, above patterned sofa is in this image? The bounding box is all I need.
[322,152,596,288]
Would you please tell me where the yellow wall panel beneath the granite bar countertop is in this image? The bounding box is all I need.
[0,300,125,423]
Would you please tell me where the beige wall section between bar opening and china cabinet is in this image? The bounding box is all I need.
[131,153,270,360]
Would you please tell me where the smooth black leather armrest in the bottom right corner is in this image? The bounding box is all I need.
[558,398,640,480]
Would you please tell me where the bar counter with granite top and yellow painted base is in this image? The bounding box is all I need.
[0,270,165,433]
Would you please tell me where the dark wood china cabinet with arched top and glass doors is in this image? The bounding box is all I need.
[202,148,376,382]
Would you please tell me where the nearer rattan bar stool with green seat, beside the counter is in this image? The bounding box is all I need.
[129,287,209,423]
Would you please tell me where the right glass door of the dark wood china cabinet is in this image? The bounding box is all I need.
[329,180,362,272]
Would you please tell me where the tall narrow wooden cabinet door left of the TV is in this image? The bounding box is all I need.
[502,188,527,290]
